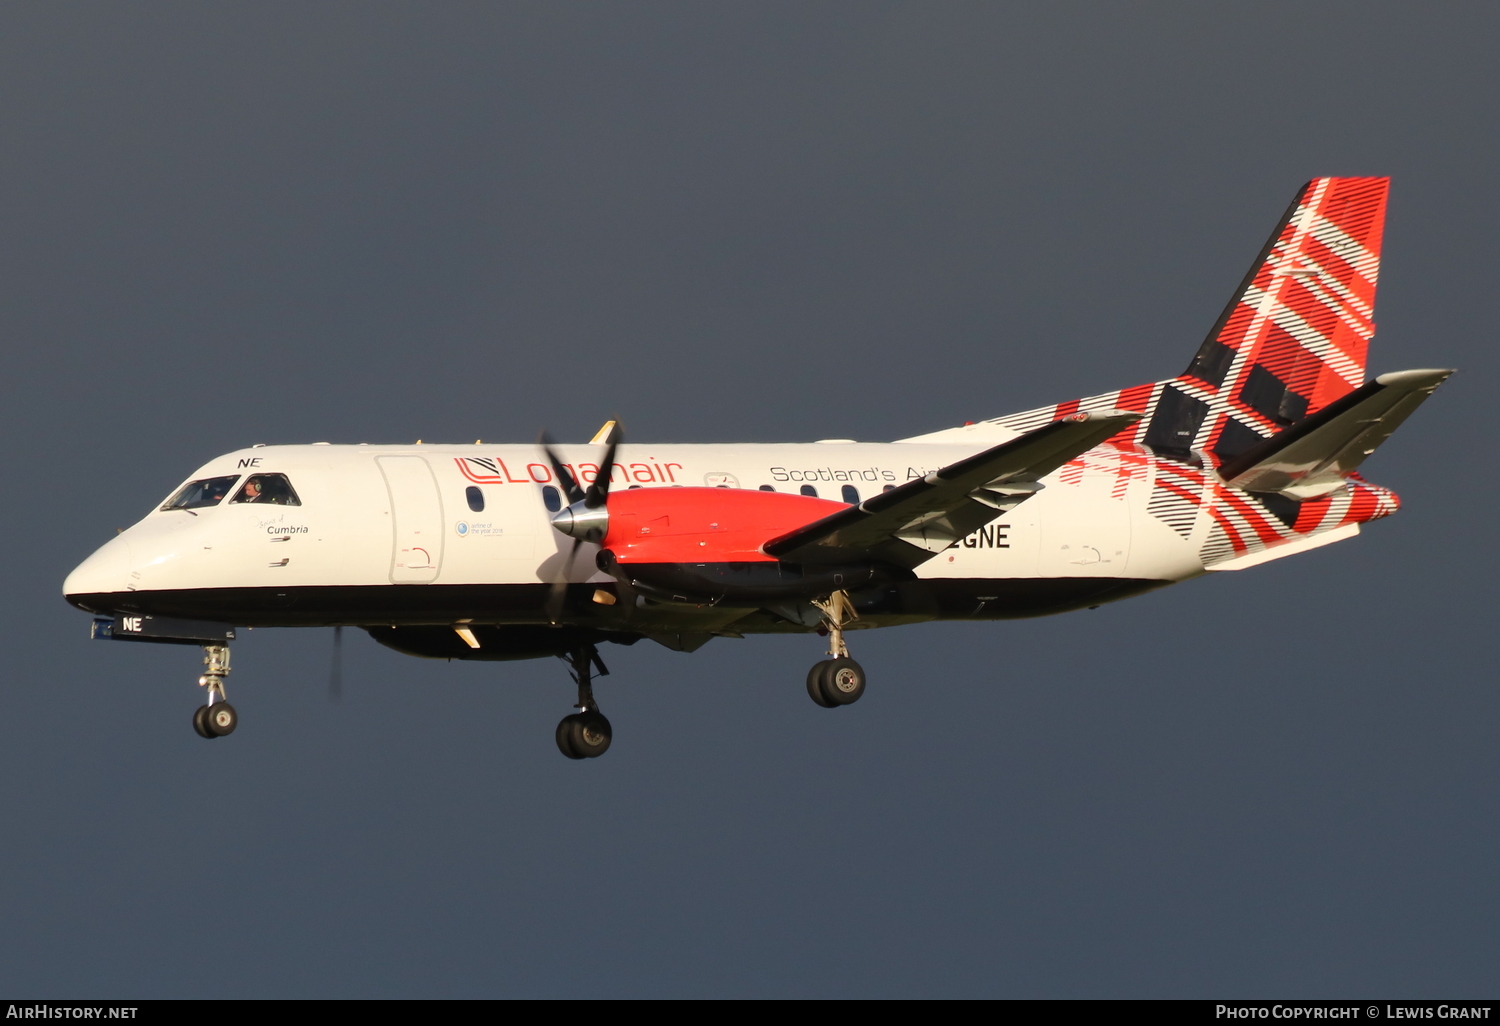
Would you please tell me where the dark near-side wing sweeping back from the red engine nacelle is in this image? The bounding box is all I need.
[762,410,1140,569]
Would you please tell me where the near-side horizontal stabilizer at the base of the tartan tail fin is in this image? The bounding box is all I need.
[1220,371,1454,500]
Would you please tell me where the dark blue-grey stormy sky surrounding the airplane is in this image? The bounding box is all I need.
[0,2,1500,998]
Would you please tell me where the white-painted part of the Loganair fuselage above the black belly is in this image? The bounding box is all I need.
[65,443,1208,630]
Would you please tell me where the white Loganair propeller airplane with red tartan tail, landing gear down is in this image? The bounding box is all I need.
[63,179,1452,759]
